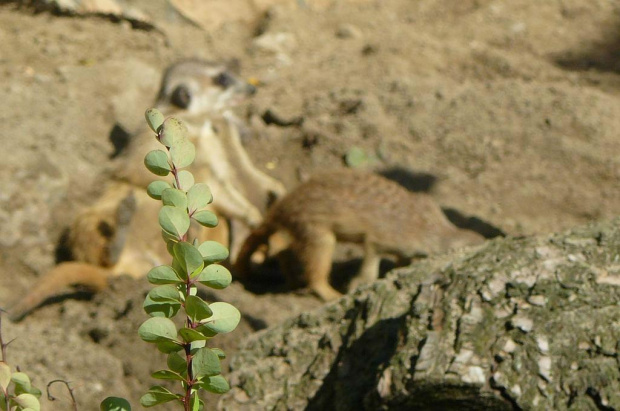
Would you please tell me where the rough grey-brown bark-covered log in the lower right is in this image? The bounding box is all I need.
[220,219,620,410]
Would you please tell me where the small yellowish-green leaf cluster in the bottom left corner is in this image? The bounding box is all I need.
[0,361,41,411]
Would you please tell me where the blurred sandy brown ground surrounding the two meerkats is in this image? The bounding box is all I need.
[0,0,620,410]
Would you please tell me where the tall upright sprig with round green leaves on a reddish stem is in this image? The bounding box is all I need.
[101,109,241,411]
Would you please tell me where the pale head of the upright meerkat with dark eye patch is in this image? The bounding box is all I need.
[157,60,256,114]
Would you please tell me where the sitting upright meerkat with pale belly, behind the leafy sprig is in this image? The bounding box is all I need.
[10,60,285,321]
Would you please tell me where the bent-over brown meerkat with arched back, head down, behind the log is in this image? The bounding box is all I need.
[235,169,483,300]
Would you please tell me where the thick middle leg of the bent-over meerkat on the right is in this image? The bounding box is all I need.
[293,229,342,301]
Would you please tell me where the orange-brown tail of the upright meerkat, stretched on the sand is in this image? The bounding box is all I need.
[9,262,111,322]
